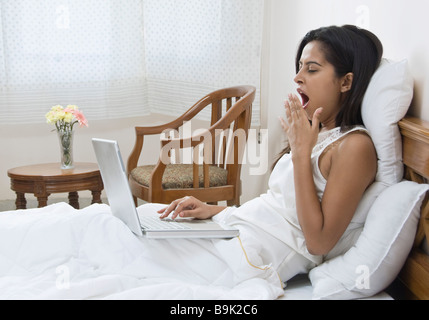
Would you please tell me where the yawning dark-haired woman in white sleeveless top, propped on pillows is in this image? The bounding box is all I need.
[159,26,383,280]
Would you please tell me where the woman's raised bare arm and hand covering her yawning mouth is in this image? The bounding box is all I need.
[282,94,377,255]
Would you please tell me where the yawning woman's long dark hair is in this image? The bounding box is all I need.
[273,25,383,168]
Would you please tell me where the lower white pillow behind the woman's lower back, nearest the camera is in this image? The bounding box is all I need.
[309,181,429,300]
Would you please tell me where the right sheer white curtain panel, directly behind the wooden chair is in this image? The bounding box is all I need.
[145,0,264,125]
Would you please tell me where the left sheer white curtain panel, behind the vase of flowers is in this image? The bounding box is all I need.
[0,0,150,123]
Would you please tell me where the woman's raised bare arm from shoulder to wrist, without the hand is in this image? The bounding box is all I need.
[293,134,377,255]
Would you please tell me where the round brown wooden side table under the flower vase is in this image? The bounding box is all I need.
[7,162,104,209]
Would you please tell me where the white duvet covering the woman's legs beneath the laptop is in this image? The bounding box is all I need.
[0,203,283,300]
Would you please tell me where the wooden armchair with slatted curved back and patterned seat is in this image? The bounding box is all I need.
[127,86,256,206]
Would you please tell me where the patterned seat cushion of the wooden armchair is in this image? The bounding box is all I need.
[131,164,228,189]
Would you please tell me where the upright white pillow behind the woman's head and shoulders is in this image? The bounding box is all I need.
[362,59,414,186]
